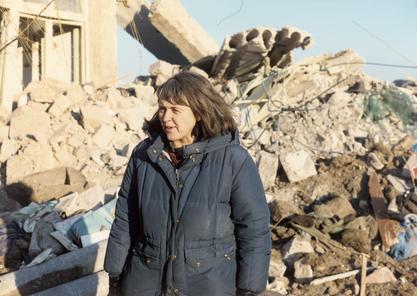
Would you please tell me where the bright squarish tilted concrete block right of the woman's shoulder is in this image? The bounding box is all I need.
[280,150,317,182]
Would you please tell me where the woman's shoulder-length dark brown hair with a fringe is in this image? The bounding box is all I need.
[144,71,237,140]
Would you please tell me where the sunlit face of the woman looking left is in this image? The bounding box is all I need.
[158,100,197,148]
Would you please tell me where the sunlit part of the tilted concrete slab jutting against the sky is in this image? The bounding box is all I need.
[149,0,219,63]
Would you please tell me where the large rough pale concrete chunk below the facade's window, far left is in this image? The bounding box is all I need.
[9,105,51,143]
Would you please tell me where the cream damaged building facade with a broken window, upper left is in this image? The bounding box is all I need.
[0,0,117,112]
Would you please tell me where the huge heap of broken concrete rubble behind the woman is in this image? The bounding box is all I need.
[0,21,417,295]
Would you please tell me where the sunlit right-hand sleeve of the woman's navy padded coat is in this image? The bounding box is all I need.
[231,152,271,293]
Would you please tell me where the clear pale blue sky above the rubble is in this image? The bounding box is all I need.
[118,0,417,82]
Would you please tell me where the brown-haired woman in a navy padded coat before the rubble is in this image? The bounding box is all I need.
[105,72,271,296]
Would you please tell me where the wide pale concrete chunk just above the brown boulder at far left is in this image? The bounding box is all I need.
[6,142,58,184]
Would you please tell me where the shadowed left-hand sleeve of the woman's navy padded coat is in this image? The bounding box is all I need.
[104,149,138,277]
